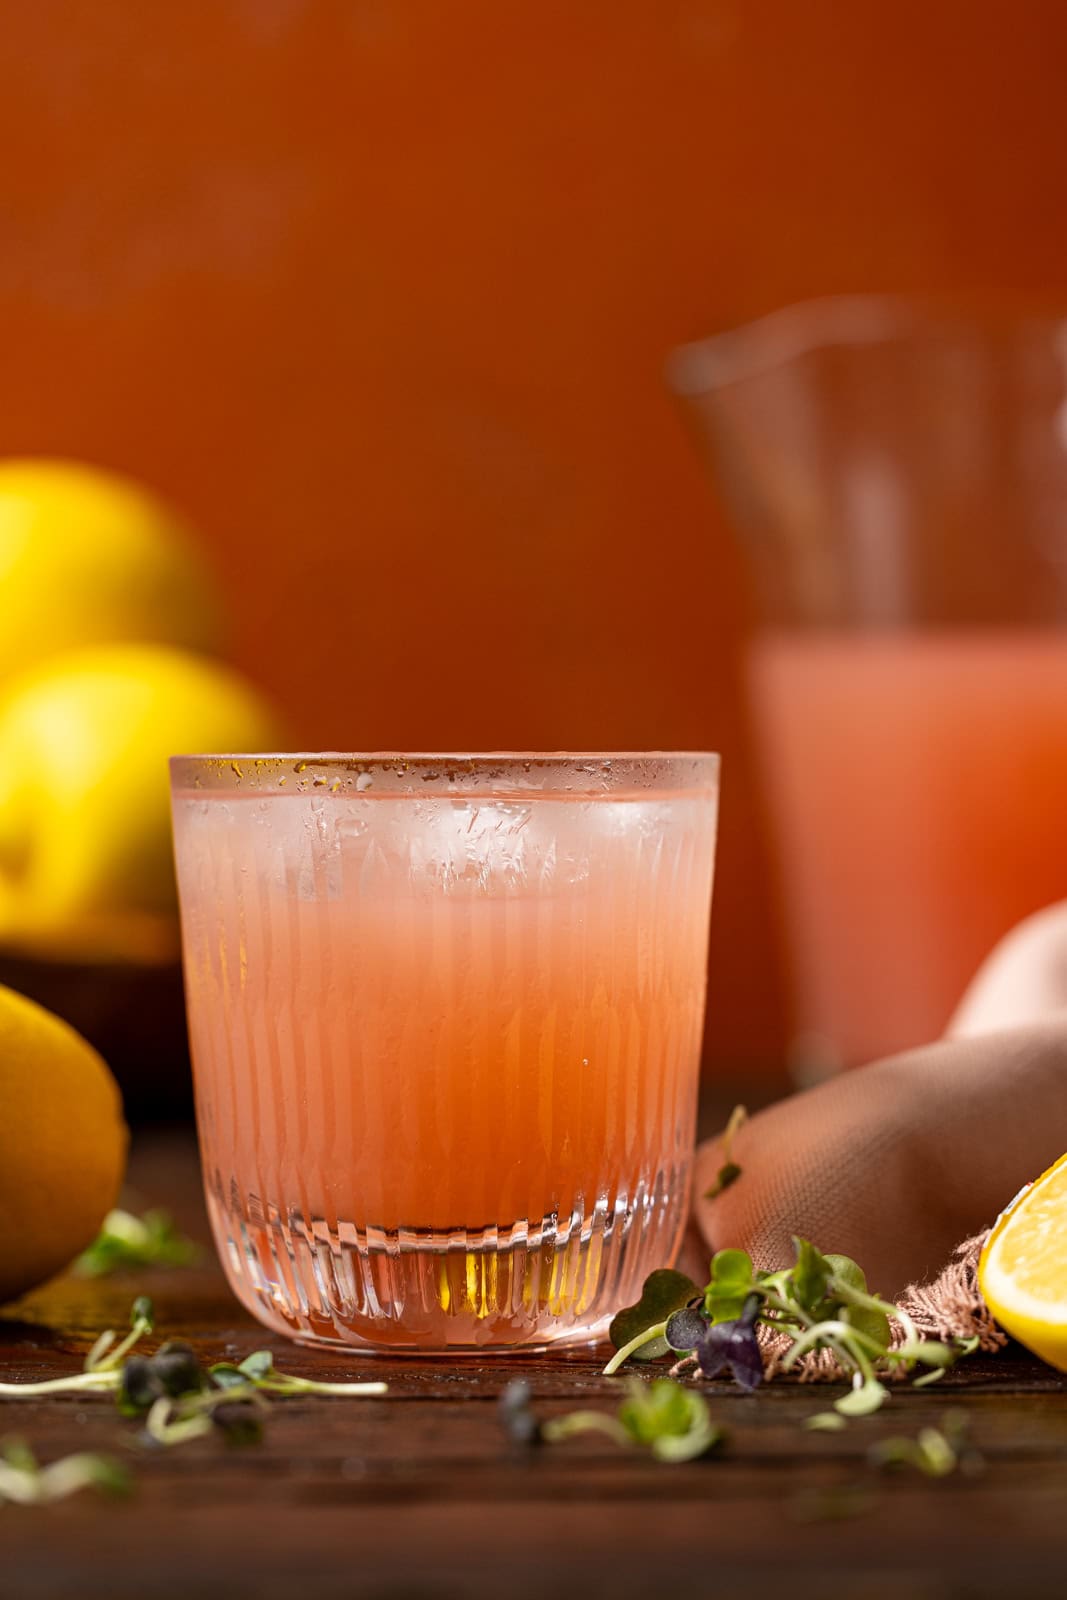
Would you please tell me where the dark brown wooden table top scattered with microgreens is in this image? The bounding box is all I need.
[0,1138,1067,1600]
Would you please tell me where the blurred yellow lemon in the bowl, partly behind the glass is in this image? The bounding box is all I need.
[0,645,283,958]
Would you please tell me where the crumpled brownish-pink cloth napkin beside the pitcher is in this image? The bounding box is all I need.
[694,902,1067,1296]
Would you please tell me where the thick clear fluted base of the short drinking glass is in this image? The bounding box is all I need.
[208,1163,688,1357]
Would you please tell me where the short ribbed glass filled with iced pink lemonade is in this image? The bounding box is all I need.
[173,755,717,1350]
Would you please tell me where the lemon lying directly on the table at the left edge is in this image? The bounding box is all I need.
[0,987,128,1304]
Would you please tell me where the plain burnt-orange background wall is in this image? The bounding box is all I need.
[0,0,1067,1062]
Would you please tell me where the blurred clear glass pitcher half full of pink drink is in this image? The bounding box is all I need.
[672,298,1067,1075]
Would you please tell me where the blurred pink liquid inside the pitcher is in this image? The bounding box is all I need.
[750,629,1067,1066]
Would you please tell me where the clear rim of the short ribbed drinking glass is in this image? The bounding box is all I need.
[170,750,720,797]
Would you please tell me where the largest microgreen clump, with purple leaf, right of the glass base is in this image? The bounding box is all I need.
[605,1238,976,1418]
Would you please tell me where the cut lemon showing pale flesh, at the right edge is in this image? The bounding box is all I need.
[977,1155,1067,1371]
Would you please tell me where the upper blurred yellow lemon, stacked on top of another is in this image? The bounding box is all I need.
[0,459,221,682]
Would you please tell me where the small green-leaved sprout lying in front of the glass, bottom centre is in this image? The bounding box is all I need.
[501,1378,723,1462]
